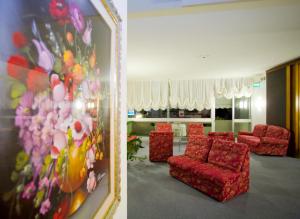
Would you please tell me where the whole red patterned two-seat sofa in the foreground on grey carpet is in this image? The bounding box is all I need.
[168,136,249,202]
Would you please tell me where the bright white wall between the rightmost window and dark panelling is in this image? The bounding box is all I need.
[251,74,267,130]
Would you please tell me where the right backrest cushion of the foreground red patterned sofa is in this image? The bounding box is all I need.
[208,139,248,172]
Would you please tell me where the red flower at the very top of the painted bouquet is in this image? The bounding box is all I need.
[49,0,70,25]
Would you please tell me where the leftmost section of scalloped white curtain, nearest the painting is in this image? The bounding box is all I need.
[127,81,169,111]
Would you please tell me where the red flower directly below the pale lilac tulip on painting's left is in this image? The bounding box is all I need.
[26,67,49,92]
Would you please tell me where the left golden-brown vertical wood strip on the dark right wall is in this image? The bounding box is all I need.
[285,65,291,129]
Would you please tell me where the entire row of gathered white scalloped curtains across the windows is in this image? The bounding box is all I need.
[127,78,253,111]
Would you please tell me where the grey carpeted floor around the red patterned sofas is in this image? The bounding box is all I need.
[127,137,300,219]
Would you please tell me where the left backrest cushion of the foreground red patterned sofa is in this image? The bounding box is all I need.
[184,135,212,162]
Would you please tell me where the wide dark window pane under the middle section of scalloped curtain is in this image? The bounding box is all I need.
[170,108,211,118]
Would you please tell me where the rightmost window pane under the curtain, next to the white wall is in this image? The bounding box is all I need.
[234,97,251,119]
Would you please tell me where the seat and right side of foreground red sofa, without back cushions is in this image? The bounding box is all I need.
[168,141,250,201]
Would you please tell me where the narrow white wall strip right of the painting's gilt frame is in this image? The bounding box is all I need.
[113,0,127,219]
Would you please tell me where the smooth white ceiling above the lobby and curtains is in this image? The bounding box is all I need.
[127,0,300,79]
